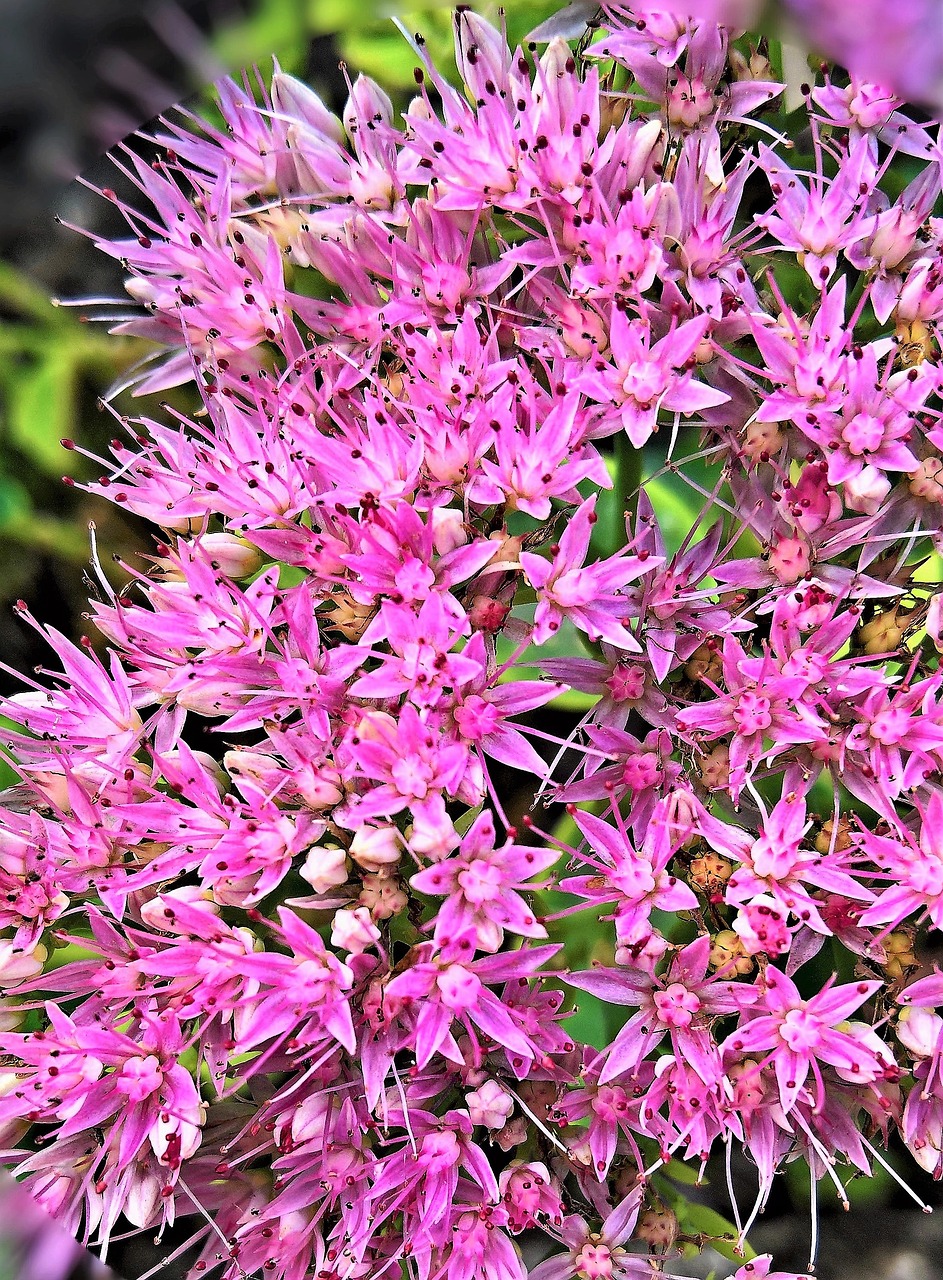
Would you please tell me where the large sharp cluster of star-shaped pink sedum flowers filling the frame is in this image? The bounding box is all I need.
[0,5,943,1280]
